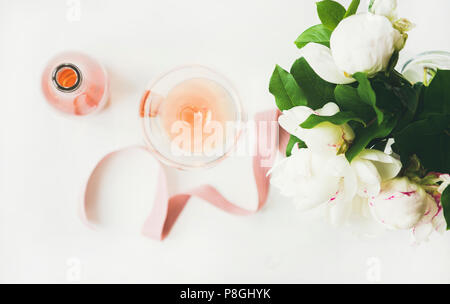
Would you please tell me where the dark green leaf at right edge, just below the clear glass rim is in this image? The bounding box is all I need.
[420,70,450,118]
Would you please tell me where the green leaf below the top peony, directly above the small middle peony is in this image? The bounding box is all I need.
[334,85,375,123]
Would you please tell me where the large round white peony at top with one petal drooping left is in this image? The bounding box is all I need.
[301,13,405,84]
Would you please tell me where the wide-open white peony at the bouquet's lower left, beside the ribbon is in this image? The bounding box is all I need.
[269,146,401,224]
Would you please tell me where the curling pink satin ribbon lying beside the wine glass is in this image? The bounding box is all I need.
[81,111,289,240]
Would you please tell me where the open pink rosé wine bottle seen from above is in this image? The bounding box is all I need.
[42,52,109,116]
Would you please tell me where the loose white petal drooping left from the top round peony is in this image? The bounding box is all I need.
[301,42,355,84]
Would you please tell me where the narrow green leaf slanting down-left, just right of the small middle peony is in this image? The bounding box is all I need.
[345,116,397,162]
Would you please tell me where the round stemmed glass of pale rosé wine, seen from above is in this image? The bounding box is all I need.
[140,65,245,169]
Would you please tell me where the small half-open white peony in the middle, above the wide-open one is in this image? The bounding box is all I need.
[278,102,355,155]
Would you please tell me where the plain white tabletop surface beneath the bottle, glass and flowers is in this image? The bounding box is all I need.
[0,0,450,283]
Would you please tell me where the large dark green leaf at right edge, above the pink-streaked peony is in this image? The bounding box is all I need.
[392,114,450,173]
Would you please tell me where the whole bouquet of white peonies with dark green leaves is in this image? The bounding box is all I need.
[269,0,450,242]
